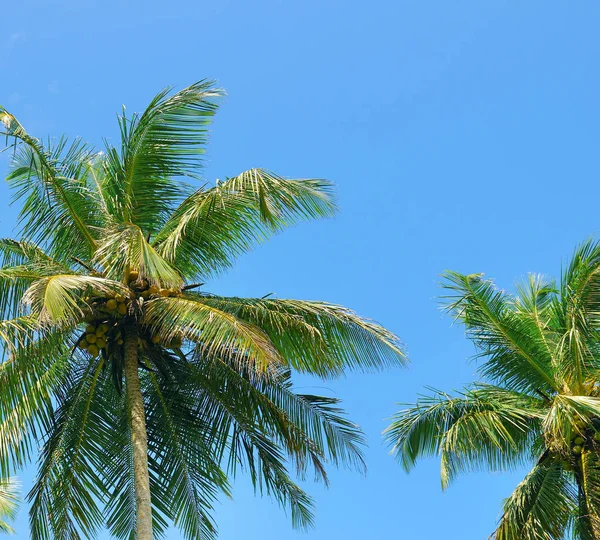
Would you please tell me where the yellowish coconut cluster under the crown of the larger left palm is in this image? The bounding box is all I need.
[77,271,182,357]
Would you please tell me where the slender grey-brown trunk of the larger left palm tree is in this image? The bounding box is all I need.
[124,326,152,540]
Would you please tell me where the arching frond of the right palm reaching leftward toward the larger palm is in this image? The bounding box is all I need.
[385,385,544,487]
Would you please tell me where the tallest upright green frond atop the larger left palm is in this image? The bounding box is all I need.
[102,81,222,234]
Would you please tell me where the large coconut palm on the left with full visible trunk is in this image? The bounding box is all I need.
[0,81,404,540]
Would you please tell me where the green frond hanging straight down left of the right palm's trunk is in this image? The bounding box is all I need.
[492,457,576,540]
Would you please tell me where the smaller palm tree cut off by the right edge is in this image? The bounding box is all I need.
[386,242,600,540]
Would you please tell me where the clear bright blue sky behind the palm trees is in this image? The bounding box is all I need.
[0,0,600,540]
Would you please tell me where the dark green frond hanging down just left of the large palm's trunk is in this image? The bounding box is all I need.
[29,359,111,540]
